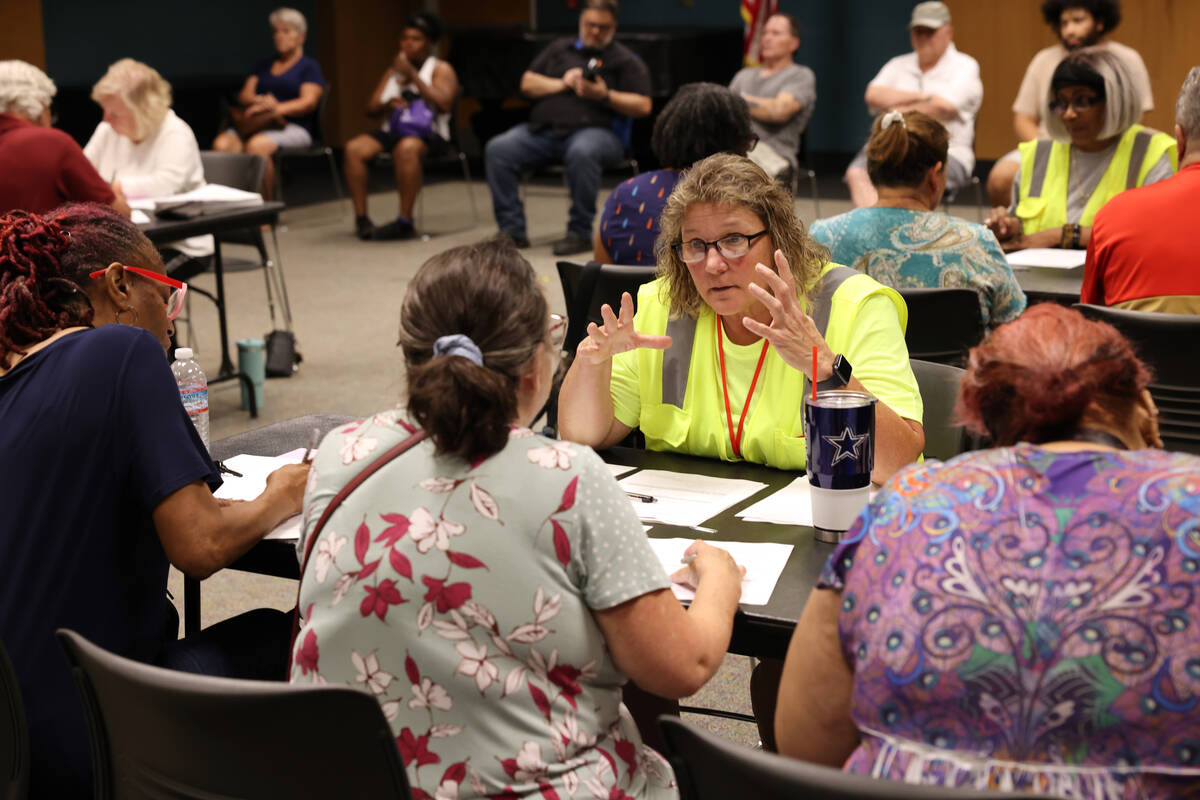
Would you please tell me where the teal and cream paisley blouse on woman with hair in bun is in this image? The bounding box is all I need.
[809,209,1025,327]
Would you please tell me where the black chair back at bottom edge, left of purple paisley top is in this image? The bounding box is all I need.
[659,716,1044,800]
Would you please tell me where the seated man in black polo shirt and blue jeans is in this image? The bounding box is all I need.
[485,0,650,255]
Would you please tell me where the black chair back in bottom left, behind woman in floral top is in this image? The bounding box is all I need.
[58,628,410,800]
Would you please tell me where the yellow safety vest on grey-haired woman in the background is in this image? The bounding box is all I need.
[1016,125,1180,235]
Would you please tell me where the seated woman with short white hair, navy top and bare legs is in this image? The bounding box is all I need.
[212,8,325,199]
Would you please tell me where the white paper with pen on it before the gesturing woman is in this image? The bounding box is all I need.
[618,469,767,528]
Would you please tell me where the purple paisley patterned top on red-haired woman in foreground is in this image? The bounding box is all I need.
[822,444,1200,798]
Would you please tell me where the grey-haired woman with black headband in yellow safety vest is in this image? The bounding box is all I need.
[988,48,1178,251]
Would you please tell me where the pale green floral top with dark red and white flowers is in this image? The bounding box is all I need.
[292,411,679,800]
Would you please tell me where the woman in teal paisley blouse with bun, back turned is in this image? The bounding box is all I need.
[810,112,1025,327]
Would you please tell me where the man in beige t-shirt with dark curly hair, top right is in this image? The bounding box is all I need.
[988,0,1154,206]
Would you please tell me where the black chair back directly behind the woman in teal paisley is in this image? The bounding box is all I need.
[896,288,984,367]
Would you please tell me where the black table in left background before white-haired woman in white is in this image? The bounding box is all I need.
[138,201,286,417]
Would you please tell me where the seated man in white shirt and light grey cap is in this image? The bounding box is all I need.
[845,1,983,207]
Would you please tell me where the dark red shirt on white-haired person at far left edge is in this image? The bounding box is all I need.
[0,114,115,213]
